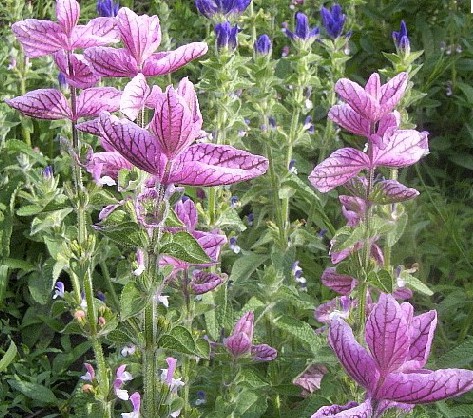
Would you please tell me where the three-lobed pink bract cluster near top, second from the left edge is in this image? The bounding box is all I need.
[85,7,208,77]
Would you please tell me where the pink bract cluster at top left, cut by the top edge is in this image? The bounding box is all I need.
[12,0,118,58]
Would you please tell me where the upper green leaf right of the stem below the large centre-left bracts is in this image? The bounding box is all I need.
[159,231,211,264]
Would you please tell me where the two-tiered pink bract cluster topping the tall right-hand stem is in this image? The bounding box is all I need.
[309,73,428,194]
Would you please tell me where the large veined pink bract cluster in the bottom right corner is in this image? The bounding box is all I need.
[312,294,473,418]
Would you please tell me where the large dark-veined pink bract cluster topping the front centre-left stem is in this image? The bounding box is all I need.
[90,78,268,186]
